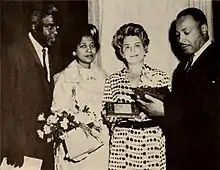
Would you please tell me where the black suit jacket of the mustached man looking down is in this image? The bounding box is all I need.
[165,43,220,170]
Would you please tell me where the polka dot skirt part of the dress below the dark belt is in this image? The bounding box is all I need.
[109,126,166,170]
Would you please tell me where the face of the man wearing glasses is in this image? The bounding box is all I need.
[37,15,58,46]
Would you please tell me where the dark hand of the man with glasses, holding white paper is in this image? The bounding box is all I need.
[7,150,24,168]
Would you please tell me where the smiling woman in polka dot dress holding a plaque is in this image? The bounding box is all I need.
[103,23,170,170]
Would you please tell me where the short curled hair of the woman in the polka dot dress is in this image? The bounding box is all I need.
[112,23,150,64]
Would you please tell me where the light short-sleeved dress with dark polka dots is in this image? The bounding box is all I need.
[103,64,171,170]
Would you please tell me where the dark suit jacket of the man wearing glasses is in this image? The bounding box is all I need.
[2,37,53,169]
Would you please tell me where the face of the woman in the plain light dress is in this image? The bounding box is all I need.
[76,36,96,68]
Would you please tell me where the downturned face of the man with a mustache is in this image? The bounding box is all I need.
[176,15,207,55]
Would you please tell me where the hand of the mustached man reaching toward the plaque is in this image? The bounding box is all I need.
[137,94,164,116]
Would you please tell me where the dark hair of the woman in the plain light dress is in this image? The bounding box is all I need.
[69,24,100,51]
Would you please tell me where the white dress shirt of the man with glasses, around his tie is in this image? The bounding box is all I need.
[28,32,50,82]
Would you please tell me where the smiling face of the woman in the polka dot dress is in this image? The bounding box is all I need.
[122,36,145,64]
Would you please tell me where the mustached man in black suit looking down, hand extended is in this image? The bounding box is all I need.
[138,8,220,170]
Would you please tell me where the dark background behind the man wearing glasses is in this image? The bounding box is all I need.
[1,0,88,72]
